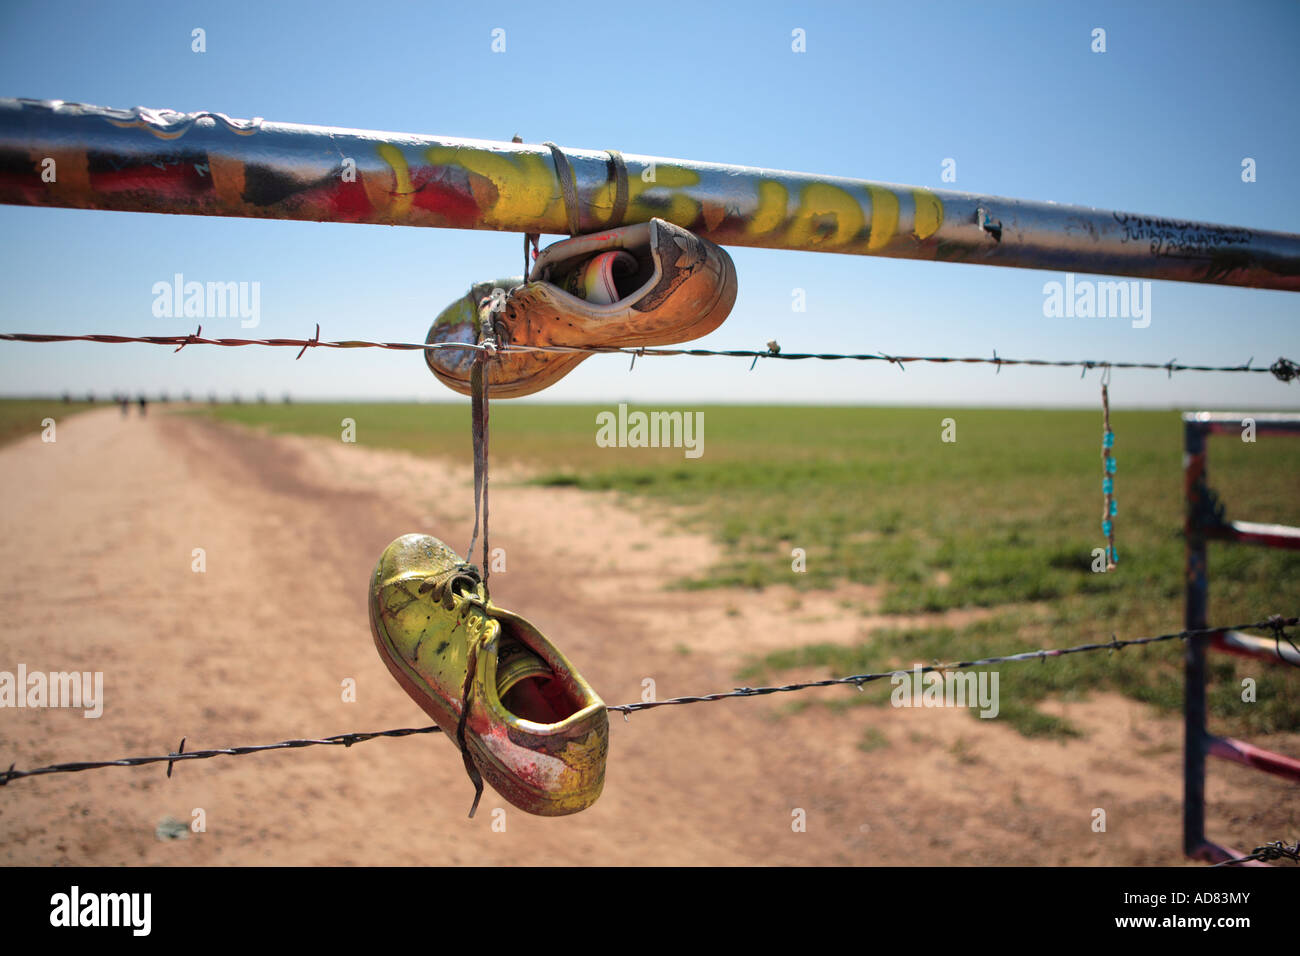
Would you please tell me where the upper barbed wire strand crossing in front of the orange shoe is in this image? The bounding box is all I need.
[0,325,1300,382]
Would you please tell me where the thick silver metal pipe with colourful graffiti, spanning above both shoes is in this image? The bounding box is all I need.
[0,99,1300,291]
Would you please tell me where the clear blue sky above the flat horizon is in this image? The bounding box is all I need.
[0,0,1300,408]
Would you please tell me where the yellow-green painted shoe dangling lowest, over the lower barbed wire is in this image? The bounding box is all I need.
[369,535,610,817]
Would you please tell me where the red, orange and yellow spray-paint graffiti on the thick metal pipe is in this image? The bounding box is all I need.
[0,100,944,252]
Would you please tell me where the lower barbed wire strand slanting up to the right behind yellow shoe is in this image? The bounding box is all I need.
[0,614,1300,787]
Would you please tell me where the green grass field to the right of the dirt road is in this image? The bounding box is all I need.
[195,402,1300,735]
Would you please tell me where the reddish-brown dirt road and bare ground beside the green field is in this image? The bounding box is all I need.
[0,410,1300,865]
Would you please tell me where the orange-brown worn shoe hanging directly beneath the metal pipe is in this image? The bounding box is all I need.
[424,219,736,398]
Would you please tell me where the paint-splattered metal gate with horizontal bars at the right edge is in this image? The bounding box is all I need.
[1183,412,1300,862]
